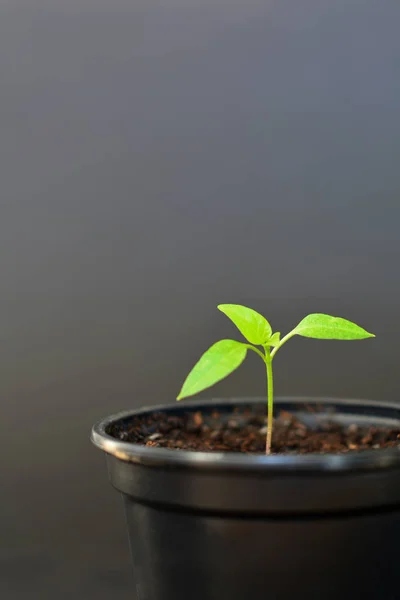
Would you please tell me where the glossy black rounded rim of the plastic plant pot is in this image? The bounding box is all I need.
[91,396,400,474]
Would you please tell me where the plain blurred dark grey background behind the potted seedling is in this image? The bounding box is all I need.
[0,0,400,600]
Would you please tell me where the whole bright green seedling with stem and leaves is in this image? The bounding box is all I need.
[177,304,375,454]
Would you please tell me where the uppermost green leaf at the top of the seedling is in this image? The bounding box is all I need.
[218,304,272,345]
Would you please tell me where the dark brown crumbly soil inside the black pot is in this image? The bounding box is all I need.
[109,409,400,454]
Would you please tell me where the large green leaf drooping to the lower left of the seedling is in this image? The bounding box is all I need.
[177,340,248,400]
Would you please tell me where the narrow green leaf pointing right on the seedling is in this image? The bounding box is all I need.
[292,314,375,340]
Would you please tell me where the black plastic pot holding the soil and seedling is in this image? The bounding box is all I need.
[92,398,400,600]
